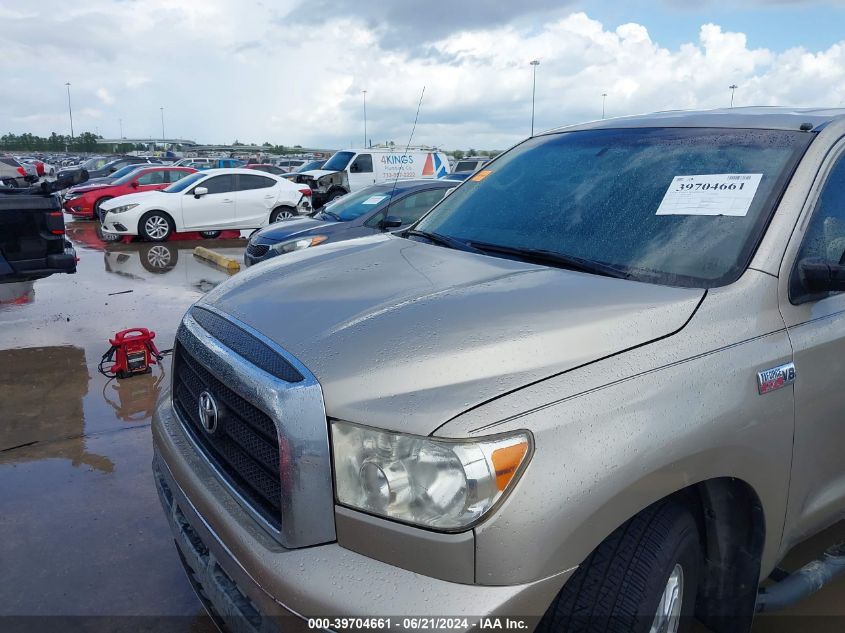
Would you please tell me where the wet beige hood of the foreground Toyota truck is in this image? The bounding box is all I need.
[201,235,704,435]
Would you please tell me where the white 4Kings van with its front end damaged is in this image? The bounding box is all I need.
[296,148,449,209]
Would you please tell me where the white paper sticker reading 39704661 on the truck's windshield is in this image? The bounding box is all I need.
[657,174,763,217]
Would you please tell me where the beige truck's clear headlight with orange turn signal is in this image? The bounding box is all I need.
[332,422,531,532]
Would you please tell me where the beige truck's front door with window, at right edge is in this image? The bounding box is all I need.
[779,144,845,547]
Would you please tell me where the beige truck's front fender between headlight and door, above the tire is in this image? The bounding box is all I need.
[438,330,793,585]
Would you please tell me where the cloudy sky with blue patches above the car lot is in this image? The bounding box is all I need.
[0,0,845,149]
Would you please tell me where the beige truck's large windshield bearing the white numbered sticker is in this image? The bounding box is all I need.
[415,128,813,288]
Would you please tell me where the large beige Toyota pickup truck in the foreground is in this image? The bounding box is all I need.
[153,108,845,632]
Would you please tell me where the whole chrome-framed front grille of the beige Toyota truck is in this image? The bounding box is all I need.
[171,304,336,548]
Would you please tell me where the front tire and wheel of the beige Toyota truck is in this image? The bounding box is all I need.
[537,500,702,633]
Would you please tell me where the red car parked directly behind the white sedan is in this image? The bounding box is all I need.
[62,165,197,219]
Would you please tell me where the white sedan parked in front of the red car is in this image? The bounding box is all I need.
[100,169,311,242]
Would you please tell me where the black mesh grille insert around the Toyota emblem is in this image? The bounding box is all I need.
[173,336,282,529]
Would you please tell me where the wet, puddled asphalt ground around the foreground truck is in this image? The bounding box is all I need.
[0,218,845,633]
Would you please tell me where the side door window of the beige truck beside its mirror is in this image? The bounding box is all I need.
[789,155,845,302]
